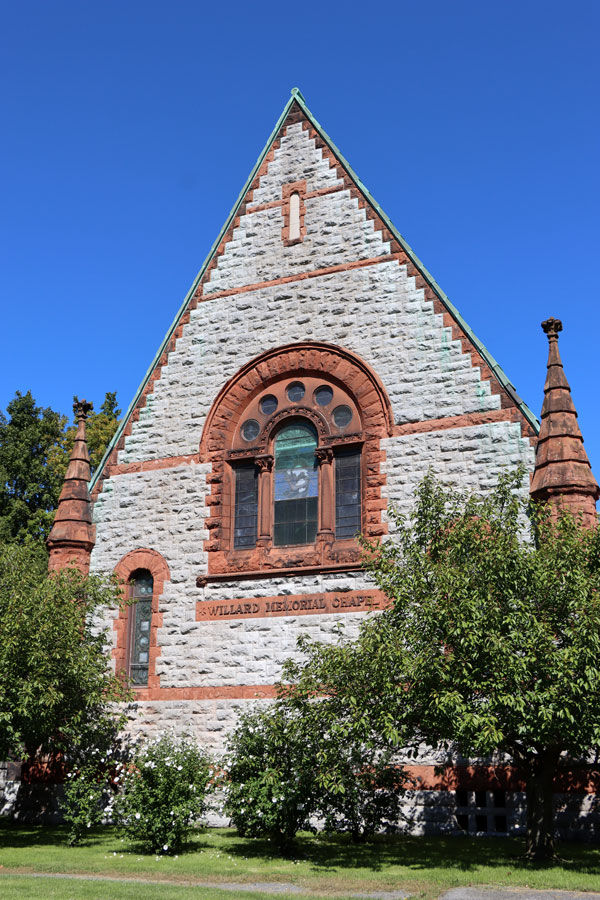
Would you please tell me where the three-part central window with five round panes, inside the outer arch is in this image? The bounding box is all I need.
[228,375,364,558]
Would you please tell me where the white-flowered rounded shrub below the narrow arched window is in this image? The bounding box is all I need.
[115,734,213,853]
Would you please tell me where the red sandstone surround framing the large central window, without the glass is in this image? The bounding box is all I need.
[200,341,392,577]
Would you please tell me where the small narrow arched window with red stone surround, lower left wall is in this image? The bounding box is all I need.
[113,548,171,698]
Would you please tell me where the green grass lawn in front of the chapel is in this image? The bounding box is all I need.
[0,823,600,900]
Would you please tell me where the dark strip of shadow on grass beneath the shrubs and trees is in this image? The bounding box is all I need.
[0,821,600,877]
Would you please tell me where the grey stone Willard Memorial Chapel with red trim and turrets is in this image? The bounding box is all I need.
[44,89,600,833]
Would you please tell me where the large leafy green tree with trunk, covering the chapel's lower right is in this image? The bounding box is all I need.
[284,473,600,859]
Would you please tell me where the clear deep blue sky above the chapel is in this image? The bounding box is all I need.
[0,0,600,478]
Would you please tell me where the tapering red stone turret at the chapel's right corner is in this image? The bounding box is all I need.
[530,318,600,526]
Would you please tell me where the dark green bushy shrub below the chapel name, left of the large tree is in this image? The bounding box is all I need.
[224,704,316,849]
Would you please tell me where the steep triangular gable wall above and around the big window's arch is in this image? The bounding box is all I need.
[93,89,538,496]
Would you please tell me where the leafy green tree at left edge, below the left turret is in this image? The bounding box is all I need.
[0,544,128,759]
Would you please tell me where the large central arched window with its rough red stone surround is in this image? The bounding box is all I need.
[199,342,391,583]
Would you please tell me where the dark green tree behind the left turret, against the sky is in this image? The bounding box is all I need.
[0,391,66,542]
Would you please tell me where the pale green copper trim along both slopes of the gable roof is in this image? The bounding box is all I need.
[90,87,540,491]
